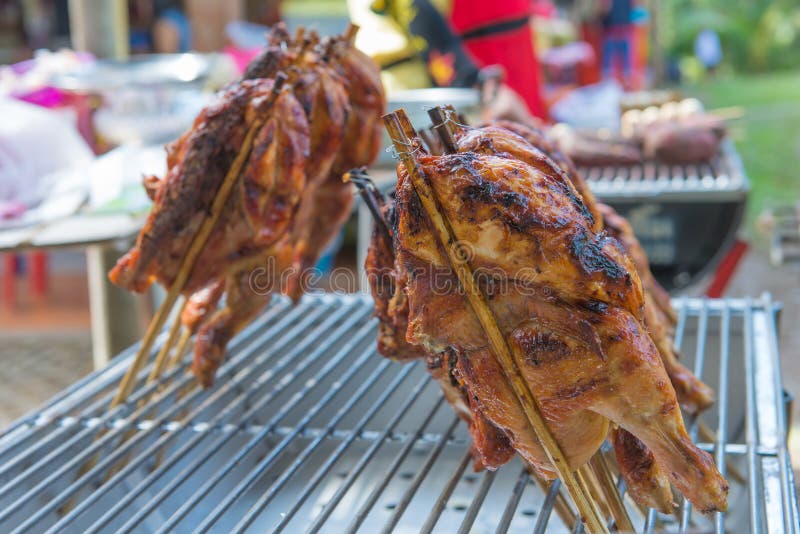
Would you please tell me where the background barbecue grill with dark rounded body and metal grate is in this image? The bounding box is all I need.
[580,140,750,289]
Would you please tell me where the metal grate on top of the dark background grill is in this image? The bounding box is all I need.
[579,140,749,199]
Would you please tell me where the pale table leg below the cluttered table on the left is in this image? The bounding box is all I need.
[86,245,142,369]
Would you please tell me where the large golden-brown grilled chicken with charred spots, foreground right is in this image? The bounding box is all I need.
[367,118,727,511]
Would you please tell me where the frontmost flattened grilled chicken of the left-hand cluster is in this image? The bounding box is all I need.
[110,79,309,293]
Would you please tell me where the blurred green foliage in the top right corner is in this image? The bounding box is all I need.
[661,0,800,72]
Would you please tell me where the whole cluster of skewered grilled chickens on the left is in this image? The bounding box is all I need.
[110,25,385,387]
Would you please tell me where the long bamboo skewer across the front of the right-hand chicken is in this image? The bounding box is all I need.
[383,110,608,533]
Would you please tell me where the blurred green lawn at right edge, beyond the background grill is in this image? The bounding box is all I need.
[686,72,800,239]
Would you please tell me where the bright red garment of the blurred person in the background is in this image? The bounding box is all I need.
[450,0,546,118]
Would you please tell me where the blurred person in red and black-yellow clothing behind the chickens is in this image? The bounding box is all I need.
[348,0,546,122]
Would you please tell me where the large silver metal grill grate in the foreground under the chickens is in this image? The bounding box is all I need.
[0,295,798,532]
